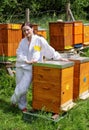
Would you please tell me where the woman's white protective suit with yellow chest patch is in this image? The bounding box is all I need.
[11,35,61,110]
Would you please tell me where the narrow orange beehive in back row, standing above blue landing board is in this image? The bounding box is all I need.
[73,21,83,44]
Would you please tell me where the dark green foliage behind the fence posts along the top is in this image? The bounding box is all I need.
[0,0,89,23]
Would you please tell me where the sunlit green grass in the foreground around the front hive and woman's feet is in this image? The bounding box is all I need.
[0,68,89,130]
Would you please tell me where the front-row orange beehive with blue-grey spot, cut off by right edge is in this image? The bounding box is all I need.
[71,57,89,100]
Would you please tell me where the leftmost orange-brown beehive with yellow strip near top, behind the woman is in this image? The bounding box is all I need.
[0,24,22,56]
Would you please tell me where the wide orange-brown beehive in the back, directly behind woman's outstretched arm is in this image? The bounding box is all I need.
[49,22,73,51]
